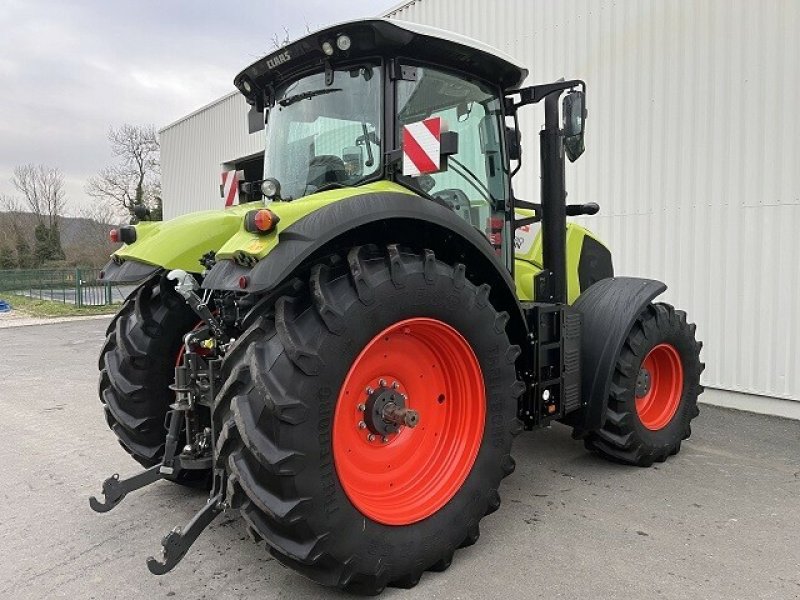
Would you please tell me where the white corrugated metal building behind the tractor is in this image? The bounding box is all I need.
[161,0,800,410]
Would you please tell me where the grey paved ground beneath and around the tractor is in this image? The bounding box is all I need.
[0,320,800,600]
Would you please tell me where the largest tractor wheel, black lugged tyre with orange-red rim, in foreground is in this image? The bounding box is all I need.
[213,246,524,594]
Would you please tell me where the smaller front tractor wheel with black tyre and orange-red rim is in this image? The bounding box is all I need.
[584,303,705,467]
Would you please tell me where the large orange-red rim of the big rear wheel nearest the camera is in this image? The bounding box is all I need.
[332,318,486,525]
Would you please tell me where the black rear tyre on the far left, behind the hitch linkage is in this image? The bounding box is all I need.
[99,274,206,482]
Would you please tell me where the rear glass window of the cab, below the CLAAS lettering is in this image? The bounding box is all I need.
[264,65,381,200]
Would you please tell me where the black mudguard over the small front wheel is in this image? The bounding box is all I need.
[570,277,667,431]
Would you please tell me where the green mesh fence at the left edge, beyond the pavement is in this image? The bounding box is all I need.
[0,267,132,307]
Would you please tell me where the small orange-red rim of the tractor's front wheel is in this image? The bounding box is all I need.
[636,344,683,431]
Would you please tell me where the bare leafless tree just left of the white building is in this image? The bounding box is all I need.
[85,125,161,215]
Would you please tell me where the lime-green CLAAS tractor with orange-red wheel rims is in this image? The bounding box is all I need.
[90,19,703,594]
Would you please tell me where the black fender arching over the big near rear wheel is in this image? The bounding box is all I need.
[203,192,527,349]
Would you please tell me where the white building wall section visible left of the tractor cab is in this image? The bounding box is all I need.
[159,92,264,219]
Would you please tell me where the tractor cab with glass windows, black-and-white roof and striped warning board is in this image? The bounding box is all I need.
[235,19,527,247]
